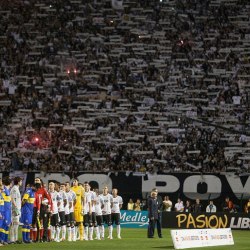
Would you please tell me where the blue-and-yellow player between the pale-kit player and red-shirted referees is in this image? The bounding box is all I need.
[20,186,36,243]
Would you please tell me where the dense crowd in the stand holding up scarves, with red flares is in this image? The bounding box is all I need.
[0,0,250,174]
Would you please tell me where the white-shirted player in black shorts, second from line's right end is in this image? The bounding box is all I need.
[100,186,113,240]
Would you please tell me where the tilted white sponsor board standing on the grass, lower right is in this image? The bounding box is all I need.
[171,228,234,249]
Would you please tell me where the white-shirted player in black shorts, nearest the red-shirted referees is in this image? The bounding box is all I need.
[49,182,61,242]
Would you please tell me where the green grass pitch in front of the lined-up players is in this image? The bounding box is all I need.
[4,229,250,250]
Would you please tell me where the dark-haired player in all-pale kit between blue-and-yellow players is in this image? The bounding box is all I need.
[10,177,23,242]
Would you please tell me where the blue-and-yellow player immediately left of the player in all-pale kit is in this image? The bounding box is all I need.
[2,177,11,244]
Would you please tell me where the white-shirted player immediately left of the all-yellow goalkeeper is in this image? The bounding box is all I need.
[65,182,76,241]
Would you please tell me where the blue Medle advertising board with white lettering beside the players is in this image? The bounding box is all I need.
[121,210,148,228]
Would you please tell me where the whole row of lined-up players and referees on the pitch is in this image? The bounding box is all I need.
[0,177,123,244]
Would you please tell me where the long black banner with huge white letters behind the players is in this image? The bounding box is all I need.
[0,172,250,207]
